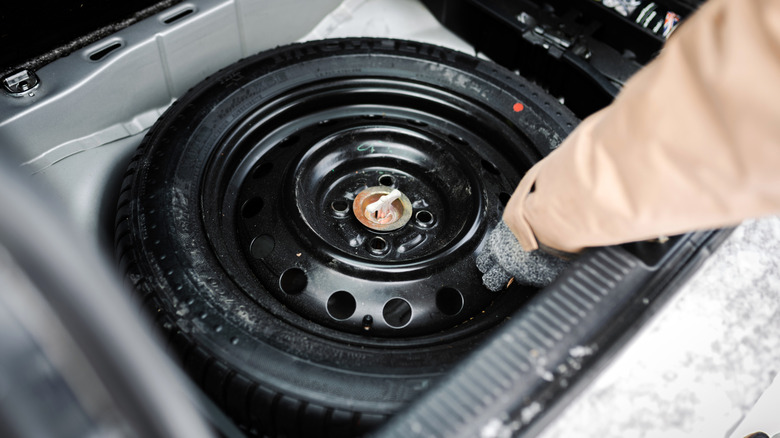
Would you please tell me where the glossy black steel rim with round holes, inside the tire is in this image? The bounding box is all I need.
[202,78,531,338]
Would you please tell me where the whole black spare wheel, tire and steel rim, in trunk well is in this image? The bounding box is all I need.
[117,39,577,437]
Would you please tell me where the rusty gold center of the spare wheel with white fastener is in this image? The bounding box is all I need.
[352,186,412,231]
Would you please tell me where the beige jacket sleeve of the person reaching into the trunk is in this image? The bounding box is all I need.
[504,0,780,252]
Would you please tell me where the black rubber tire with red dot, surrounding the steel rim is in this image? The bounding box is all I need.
[115,39,577,437]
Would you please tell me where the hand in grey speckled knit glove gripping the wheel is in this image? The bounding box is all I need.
[477,220,570,292]
